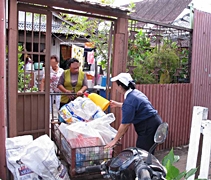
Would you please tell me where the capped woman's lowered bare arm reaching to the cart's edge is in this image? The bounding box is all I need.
[105,124,131,148]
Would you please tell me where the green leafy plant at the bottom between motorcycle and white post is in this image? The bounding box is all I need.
[162,148,197,180]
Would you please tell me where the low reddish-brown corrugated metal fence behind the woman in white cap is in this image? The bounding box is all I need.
[115,84,192,149]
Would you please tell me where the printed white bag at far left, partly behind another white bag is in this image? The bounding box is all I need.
[5,135,39,180]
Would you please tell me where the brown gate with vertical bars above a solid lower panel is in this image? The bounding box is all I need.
[9,3,52,138]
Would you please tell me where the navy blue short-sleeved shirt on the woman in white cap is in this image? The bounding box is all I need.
[122,89,157,124]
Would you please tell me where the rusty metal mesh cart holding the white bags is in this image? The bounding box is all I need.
[51,93,122,180]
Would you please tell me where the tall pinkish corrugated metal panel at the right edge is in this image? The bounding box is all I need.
[191,10,211,119]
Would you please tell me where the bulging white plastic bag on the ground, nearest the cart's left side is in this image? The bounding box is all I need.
[21,135,70,180]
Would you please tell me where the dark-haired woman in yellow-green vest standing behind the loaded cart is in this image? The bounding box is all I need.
[57,58,87,108]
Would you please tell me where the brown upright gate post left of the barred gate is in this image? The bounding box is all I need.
[7,0,18,137]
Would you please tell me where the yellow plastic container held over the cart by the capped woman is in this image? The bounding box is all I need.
[84,92,110,111]
